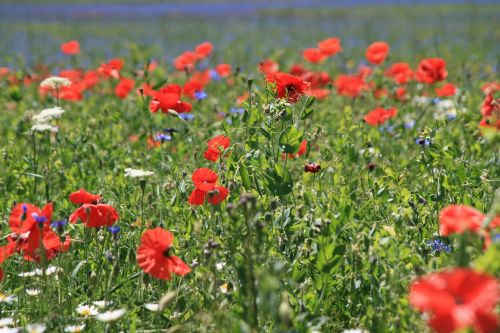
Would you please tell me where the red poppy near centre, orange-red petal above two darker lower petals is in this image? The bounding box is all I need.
[189,168,229,205]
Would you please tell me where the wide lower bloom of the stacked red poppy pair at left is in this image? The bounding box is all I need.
[69,204,120,228]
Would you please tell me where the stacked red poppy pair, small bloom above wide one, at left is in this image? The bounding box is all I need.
[69,189,120,228]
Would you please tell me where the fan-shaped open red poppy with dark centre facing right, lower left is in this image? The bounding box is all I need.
[137,228,191,280]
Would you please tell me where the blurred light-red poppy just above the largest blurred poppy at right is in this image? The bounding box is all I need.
[439,205,484,236]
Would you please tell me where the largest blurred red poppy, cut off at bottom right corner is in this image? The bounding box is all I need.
[410,268,499,333]
